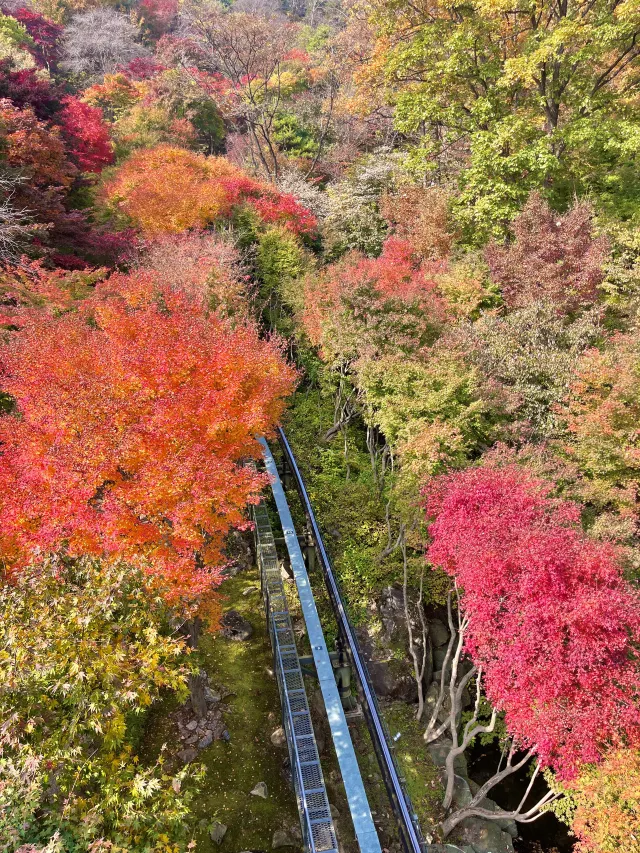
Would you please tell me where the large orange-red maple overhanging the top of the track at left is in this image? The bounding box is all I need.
[0,270,295,601]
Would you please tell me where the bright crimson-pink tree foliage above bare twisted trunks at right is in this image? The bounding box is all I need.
[426,466,640,778]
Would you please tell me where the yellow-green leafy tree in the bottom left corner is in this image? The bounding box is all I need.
[0,558,200,853]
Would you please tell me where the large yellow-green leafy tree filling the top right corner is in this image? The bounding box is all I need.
[359,0,640,236]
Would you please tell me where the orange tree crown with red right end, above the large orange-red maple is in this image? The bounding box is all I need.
[106,145,316,235]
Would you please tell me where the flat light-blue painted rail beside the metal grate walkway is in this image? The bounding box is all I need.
[259,438,381,853]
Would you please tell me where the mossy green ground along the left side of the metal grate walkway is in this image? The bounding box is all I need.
[139,569,298,853]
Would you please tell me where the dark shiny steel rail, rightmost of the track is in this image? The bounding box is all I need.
[277,427,428,853]
